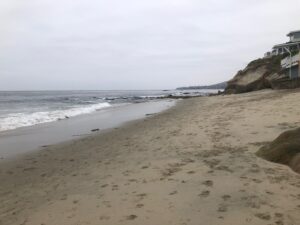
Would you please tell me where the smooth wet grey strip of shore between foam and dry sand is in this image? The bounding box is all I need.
[0,100,176,159]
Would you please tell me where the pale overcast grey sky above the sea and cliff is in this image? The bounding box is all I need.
[0,0,300,90]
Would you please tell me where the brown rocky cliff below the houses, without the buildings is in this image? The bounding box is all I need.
[225,56,286,94]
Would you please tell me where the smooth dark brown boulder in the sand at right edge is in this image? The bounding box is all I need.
[256,128,300,173]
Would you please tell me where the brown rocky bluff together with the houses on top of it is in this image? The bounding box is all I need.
[225,30,300,94]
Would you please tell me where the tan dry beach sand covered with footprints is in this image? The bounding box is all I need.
[0,90,300,225]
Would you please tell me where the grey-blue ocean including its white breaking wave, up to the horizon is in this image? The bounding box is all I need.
[0,90,217,132]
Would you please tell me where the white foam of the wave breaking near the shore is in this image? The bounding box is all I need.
[0,102,111,131]
